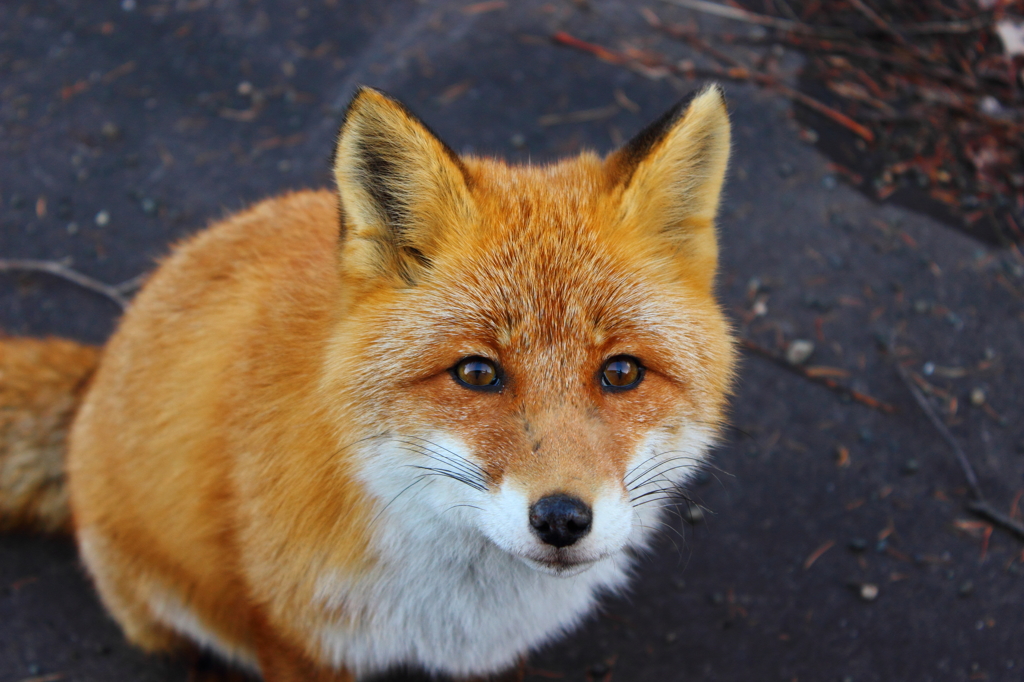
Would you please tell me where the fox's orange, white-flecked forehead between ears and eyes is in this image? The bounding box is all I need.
[364,155,713,360]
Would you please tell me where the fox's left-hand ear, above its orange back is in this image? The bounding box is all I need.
[334,87,472,287]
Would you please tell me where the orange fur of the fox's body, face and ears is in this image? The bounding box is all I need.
[61,90,733,681]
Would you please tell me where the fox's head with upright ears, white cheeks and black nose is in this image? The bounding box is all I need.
[325,87,734,574]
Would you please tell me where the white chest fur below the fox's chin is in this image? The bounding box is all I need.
[309,504,630,676]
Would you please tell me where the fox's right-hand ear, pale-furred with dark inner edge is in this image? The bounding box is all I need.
[605,85,729,288]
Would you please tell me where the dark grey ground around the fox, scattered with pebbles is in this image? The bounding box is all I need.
[0,0,1024,682]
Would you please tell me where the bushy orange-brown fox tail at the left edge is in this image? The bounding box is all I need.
[0,337,100,532]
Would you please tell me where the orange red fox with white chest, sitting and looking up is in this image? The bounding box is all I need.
[0,87,735,682]
